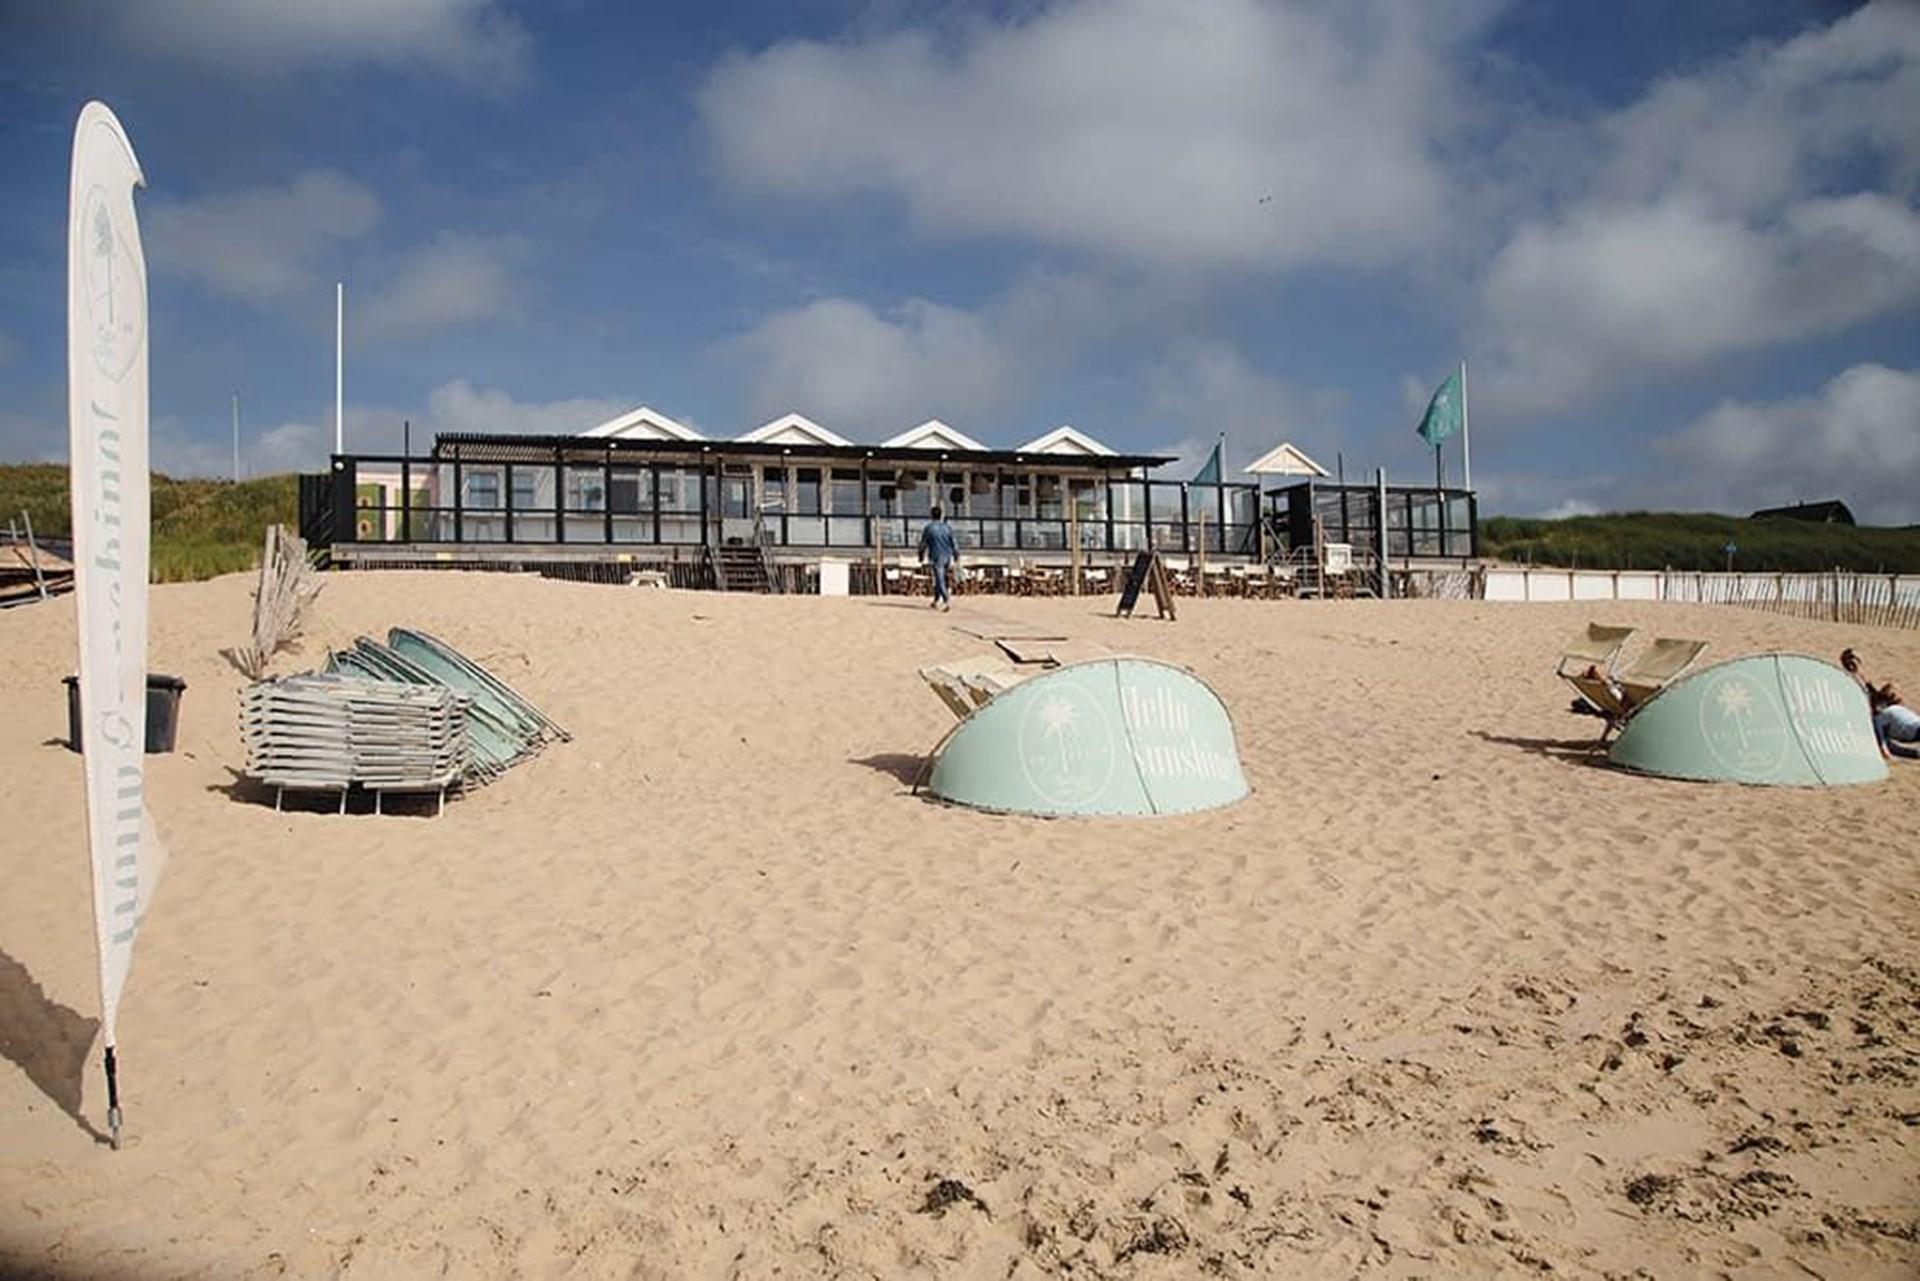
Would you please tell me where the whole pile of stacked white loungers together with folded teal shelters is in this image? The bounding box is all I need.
[240,628,570,812]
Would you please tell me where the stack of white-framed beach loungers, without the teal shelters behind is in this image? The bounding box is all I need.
[240,674,470,812]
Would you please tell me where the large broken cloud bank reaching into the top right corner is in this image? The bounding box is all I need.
[1471,6,1920,417]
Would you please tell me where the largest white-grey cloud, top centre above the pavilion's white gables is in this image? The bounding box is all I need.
[699,0,1475,269]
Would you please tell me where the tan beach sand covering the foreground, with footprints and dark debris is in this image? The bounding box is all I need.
[0,572,1920,1277]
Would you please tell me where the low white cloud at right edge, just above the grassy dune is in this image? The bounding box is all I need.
[1655,365,1920,524]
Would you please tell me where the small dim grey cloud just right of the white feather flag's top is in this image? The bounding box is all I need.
[144,169,380,303]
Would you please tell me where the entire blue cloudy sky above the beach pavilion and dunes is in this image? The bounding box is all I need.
[0,0,1920,524]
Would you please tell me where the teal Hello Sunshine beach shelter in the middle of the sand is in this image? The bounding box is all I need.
[927,657,1248,814]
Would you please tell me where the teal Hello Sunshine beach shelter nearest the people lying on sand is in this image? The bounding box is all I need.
[1607,653,1887,787]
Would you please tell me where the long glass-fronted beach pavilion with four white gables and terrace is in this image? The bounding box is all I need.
[301,409,1476,593]
